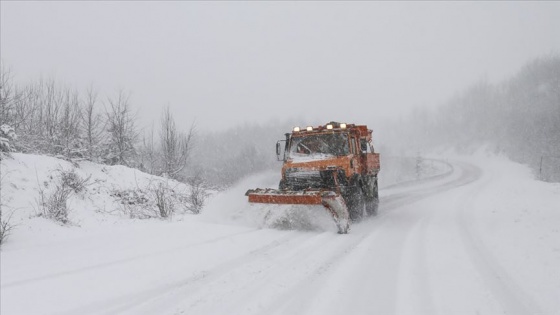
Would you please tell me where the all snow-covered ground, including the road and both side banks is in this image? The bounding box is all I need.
[0,154,560,315]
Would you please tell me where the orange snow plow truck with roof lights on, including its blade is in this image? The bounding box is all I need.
[245,122,380,234]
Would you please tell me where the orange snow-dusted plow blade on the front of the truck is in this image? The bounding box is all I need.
[245,188,350,234]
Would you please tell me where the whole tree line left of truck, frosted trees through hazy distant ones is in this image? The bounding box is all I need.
[0,65,296,189]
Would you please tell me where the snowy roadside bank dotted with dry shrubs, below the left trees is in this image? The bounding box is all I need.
[1,153,201,247]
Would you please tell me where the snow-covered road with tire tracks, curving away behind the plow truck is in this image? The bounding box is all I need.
[2,162,539,315]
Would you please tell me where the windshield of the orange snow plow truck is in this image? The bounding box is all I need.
[288,133,348,161]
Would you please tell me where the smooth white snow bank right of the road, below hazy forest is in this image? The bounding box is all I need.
[464,152,560,314]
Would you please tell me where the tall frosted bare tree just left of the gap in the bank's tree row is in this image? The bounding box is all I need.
[105,90,138,166]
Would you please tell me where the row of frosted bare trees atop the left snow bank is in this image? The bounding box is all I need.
[0,65,195,181]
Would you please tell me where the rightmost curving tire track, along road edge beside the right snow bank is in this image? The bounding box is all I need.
[456,170,543,315]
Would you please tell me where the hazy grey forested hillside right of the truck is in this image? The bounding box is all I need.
[383,55,560,181]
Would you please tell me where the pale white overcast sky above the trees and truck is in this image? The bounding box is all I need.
[0,1,560,129]
